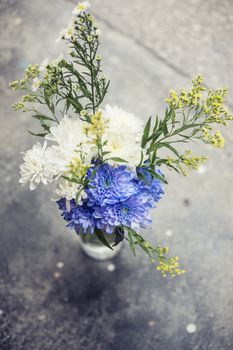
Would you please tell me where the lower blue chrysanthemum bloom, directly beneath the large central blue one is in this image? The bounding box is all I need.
[93,193,151,234]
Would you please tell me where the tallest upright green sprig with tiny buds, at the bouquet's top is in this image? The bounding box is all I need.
[63,12,109,114]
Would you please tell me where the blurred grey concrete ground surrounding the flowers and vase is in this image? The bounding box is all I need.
[0,0,233,350]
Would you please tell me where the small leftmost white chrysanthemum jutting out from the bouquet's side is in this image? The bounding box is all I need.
[19,141,57,190]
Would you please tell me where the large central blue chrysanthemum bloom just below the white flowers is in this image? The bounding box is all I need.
[86,163,137,206]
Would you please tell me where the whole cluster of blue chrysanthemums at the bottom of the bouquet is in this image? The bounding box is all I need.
[57,164,163,234]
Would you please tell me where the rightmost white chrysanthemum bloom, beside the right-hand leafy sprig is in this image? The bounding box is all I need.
[102,105,143,166]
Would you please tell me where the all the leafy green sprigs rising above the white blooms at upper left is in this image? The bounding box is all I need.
[10,12,109,136]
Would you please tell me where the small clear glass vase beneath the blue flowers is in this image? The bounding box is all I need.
[79,233,123,261]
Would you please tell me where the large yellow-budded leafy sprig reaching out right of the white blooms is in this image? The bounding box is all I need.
[140,75,233,175]
